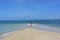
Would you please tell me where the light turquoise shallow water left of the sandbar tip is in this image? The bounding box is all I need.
[0,23,27,34]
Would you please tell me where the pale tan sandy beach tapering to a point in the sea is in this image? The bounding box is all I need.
[2,28,60,40]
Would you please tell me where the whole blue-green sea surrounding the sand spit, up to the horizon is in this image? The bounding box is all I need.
[0,20,60,37]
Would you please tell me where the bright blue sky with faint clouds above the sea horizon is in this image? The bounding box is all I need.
[0,0,60,20]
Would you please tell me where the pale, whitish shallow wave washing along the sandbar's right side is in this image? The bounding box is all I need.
[32,24,60,33]
